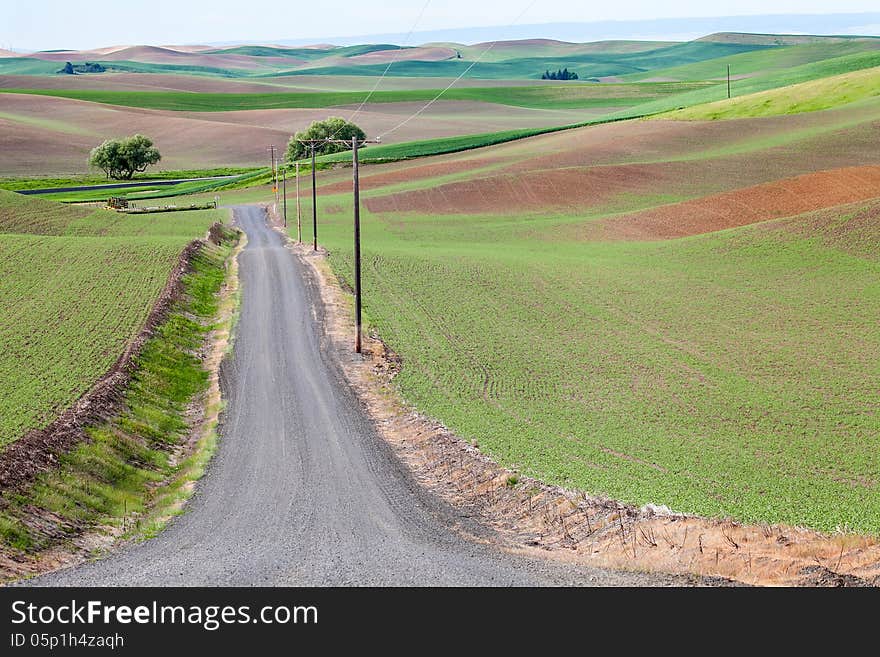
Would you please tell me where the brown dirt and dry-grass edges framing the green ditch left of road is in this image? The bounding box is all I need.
[0,224,238,582]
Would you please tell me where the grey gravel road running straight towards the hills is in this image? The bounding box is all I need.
[29,207,689,586]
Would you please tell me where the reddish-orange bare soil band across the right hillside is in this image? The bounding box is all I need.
[573,166,880,240]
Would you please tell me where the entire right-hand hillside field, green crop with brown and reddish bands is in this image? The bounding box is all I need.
[294,102,880,534]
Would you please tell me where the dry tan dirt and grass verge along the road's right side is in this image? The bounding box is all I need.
[282,206,880,586]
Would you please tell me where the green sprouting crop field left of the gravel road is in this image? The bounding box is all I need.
[0,191,227,447]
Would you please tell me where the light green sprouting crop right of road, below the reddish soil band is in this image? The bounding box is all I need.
[290,119,880,534]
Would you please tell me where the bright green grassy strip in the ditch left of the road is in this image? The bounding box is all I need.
[0,230,237,577]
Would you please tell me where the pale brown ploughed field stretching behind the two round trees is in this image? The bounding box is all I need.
[0,93,588,175]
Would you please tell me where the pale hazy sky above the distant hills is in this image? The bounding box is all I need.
[0,0,878,50]
